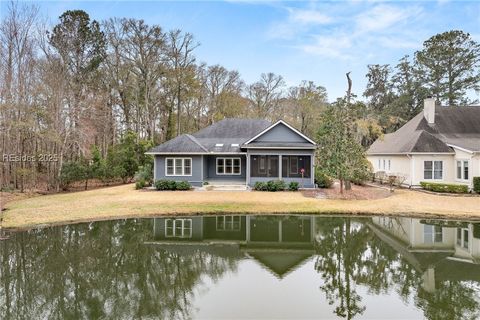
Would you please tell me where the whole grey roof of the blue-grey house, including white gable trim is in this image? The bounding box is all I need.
[147,118,315,154]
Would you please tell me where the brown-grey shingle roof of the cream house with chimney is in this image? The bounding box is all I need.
[368,106,480,154]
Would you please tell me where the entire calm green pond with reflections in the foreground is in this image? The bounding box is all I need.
[0,215,480,319]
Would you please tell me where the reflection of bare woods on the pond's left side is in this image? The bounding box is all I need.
[0,220,238,319]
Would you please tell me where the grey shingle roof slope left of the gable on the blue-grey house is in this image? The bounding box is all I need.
[149,119,271,153]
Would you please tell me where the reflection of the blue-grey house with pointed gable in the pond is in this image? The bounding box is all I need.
[151,216,315,278]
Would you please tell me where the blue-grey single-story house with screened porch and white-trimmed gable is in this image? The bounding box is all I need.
[147,119,316,188]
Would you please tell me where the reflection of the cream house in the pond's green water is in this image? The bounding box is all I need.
[368,217,480,292]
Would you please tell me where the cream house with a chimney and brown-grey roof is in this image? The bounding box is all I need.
[367,98,480,188]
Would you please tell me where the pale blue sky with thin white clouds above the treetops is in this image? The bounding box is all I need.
[0,0,480,101]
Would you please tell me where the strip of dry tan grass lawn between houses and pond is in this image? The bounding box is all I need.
[1,184,480,228]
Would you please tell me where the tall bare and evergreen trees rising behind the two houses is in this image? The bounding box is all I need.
[0,2,480,190]
